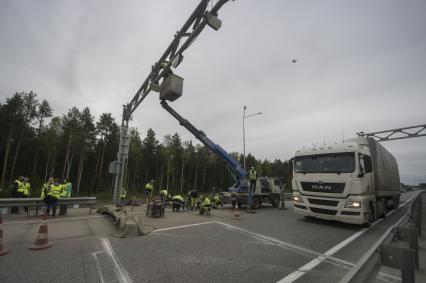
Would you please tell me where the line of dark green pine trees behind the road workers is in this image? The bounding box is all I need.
[0,91,291,197]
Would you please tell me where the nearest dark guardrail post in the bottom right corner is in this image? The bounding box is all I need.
[381,245,415,283]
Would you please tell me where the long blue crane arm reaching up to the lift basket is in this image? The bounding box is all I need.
[160,100,247,191]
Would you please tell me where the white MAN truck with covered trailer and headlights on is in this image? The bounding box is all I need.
[292,137,400,226]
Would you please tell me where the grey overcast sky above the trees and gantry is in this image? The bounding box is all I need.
[0,0,426,183]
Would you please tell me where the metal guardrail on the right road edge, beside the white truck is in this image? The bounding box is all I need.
[339,192,423,283]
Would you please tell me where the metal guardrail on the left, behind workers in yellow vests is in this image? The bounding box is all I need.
[0,197,97,215]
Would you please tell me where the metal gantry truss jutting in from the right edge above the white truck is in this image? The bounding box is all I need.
[357,124,426,142]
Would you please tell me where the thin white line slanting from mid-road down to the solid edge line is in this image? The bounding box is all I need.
[216,221,354,267]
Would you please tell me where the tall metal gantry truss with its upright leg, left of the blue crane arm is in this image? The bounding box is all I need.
[110,0,229,203]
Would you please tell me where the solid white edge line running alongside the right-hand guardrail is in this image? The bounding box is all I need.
[277,194,417,283]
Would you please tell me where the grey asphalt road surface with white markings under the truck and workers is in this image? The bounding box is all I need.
[0,192,416,283]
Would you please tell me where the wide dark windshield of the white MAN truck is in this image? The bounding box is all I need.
[294,152,355,173]
